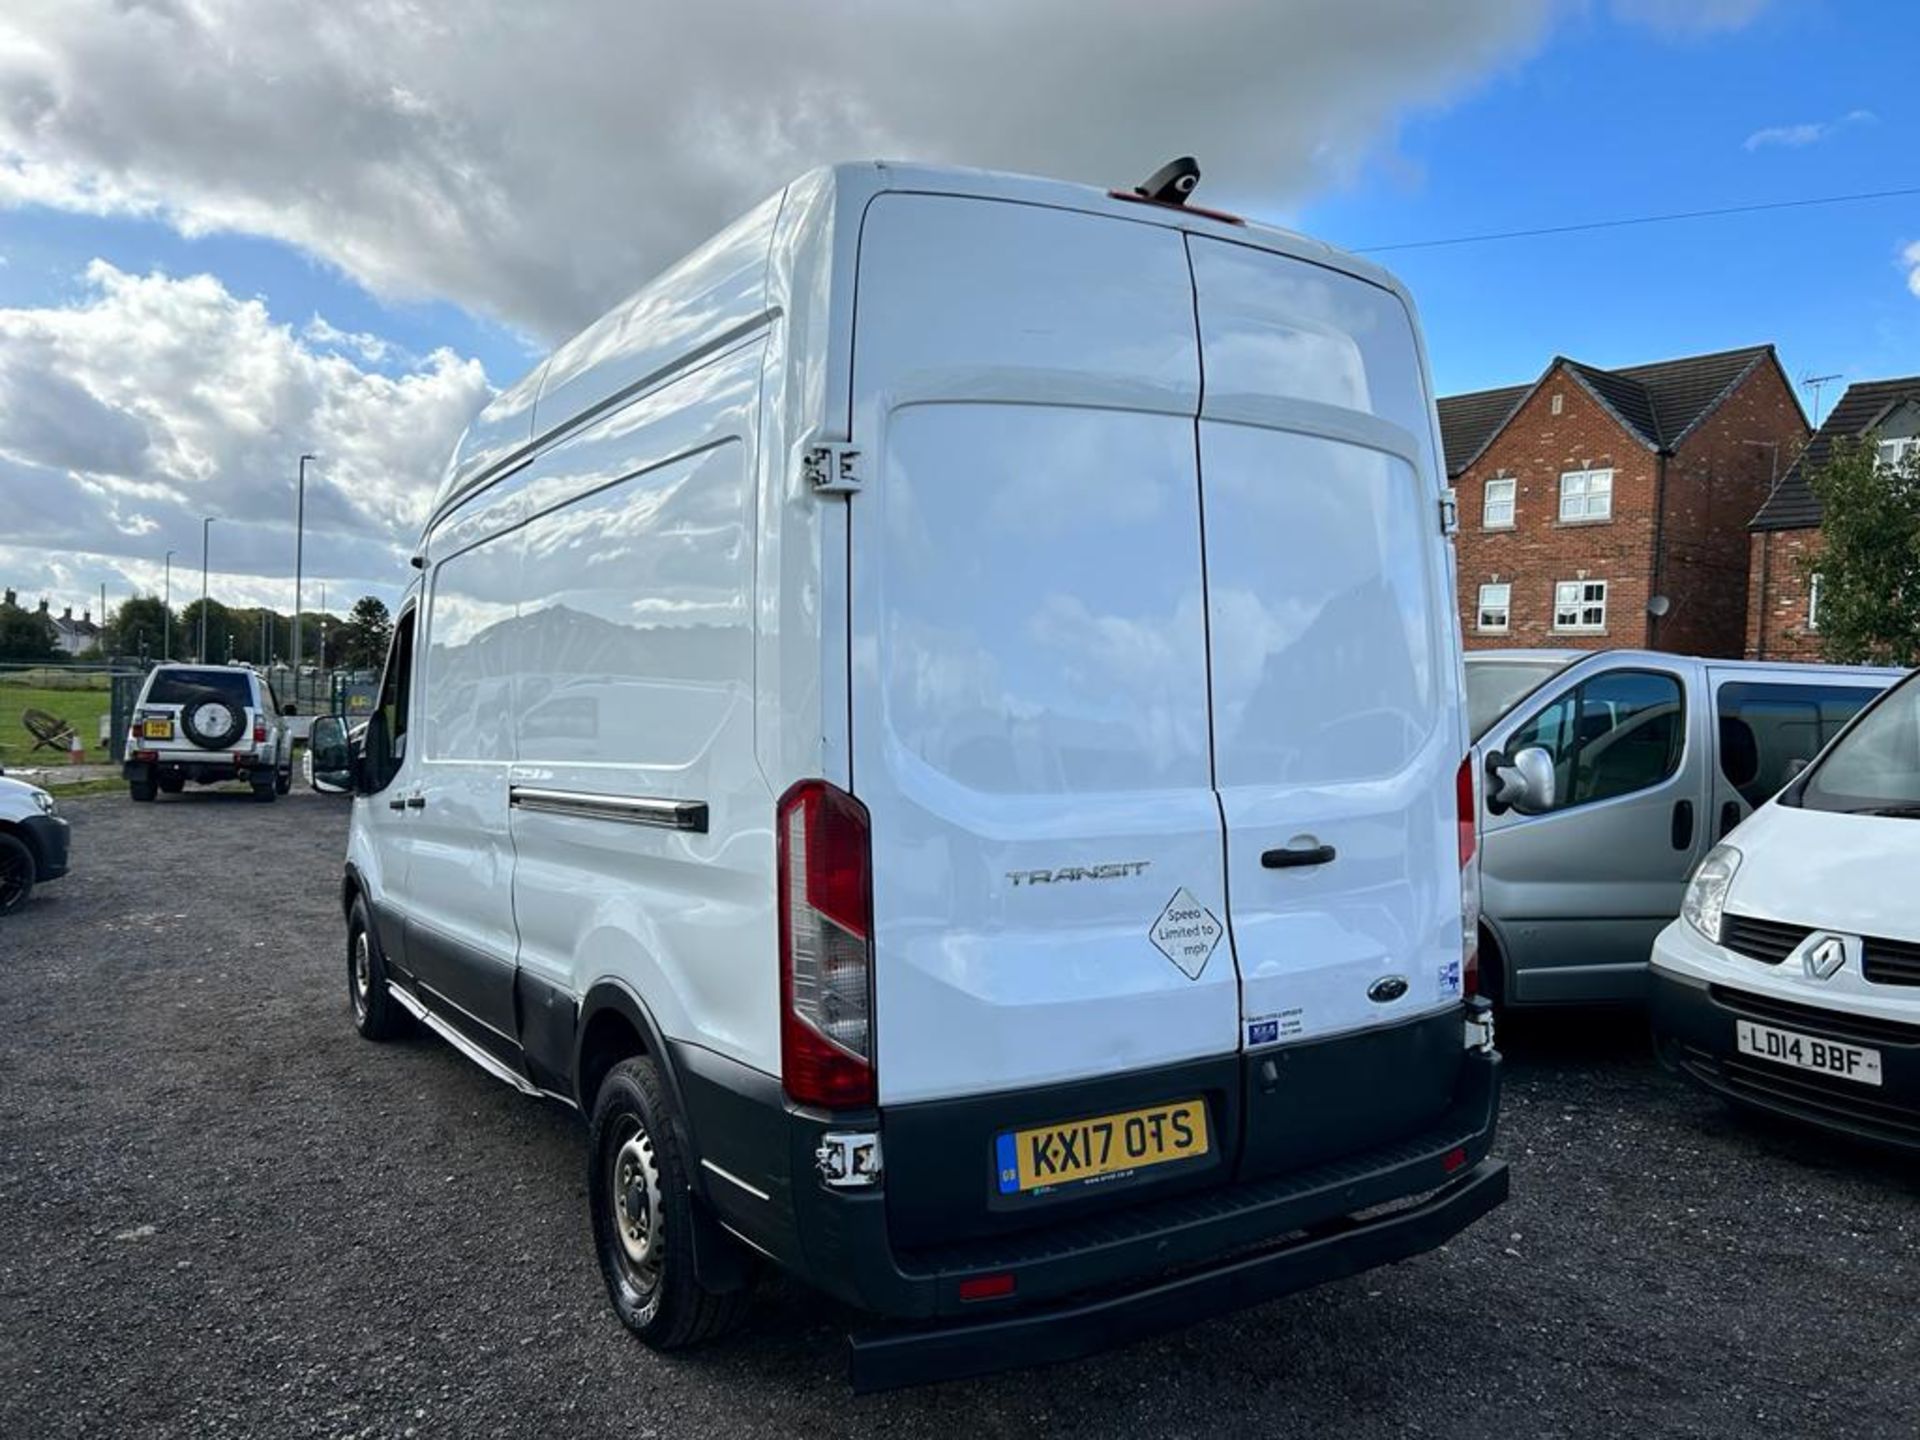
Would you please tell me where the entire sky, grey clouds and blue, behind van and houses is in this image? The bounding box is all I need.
[0,0,1920,629]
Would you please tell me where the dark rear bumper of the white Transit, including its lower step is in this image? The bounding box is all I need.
[674,1018,1507,1388]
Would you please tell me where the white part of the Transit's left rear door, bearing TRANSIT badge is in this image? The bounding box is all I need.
[851,194,1238,1105]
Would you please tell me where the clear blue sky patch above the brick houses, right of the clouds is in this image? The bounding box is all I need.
[1298,4,1920,403]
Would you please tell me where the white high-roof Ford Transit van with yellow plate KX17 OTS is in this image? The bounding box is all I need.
[315,165,1507,1388]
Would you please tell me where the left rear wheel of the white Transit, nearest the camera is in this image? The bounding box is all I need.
[588,1056,749,1350]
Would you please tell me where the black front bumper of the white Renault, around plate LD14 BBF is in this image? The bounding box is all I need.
[1649,966,1920,1152]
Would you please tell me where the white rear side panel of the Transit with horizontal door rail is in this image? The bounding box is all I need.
[511,340,780,1071]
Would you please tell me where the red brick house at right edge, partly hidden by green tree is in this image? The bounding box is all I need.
[1745,374,1920,660]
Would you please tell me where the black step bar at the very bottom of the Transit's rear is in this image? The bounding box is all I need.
[849,1160,1507,1394]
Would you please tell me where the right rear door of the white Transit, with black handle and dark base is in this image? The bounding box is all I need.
[1188,236,1465,1177]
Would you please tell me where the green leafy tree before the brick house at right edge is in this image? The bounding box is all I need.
[1801,436,1920,666]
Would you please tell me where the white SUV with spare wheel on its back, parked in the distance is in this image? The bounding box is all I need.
[121,664,294,801]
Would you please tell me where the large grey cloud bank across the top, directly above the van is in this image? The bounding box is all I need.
[0,0,1559,340]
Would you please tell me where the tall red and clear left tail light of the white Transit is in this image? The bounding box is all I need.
[776,780,874,1110]
